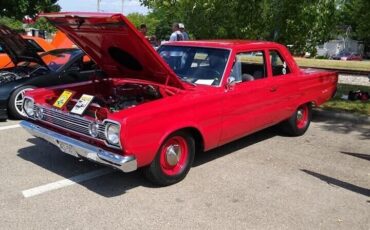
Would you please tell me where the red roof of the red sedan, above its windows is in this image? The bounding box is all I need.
[163,40,281,49]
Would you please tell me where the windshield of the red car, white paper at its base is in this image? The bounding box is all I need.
[158,45,230,86]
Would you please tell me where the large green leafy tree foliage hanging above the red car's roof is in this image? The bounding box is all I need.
[141,0,338,53]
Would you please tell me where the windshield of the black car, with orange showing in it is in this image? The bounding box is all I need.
[40,49,81,72]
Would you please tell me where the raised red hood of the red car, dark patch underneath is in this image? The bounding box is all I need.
[40,12,184,88]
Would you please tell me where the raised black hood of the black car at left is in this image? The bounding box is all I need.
[0,25,47,68]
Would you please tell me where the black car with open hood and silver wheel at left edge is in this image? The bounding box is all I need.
[0,26,96,120]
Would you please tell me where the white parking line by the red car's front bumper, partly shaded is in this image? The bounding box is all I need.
[22,168,114,198]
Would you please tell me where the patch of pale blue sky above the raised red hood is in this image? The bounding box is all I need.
[58,0,148,15]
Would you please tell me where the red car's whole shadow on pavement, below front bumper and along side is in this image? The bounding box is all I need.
[18,129,276,198]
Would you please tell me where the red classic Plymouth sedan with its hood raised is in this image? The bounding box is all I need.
[21,13,337,185]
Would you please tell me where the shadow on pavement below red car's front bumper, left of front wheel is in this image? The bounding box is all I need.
[18,138,154,198]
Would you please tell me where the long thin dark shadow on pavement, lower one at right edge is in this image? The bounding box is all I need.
[301,169,370,197]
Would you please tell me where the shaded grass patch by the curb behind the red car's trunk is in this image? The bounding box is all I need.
[321,84,370,116]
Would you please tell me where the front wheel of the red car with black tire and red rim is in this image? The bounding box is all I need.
[144,131,195,186]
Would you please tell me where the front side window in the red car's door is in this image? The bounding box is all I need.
[231,51,266,82]
